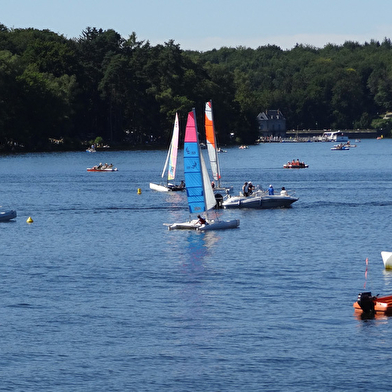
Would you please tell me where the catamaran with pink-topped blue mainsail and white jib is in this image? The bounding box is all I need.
[167,109,240,231]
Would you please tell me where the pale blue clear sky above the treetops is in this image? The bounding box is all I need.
[0,0,392,52]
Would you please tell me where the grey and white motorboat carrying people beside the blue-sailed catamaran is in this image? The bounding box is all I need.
[222,190,298,209]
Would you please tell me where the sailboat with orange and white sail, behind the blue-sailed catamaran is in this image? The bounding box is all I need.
[205,101,233,194]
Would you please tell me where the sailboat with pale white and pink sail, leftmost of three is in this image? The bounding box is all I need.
[150,113,185,192]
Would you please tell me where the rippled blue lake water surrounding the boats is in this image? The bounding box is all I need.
[0,140,392,391]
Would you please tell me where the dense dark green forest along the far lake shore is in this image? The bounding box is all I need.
[0,24,392,151]
